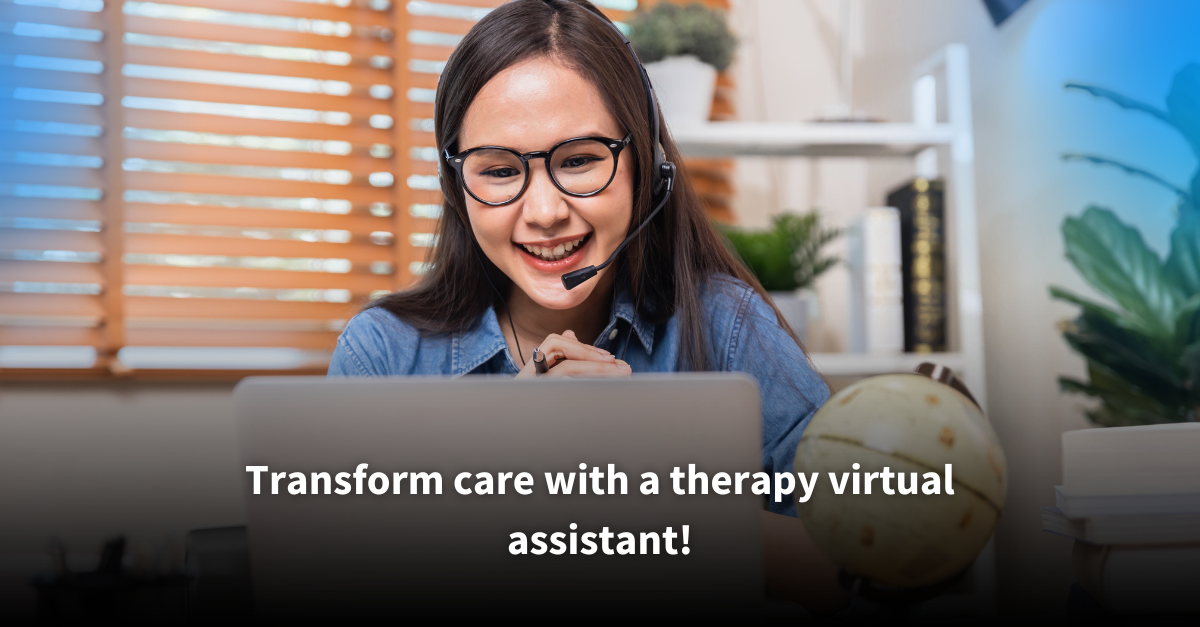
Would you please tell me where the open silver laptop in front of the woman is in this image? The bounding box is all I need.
[234,374,763,620]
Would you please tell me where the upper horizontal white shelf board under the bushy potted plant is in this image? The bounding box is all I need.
[671,121,955,157]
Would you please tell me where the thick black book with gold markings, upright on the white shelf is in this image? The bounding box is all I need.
[888,178,946,353]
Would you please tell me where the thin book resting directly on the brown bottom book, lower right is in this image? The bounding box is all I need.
[1042,507,1200,544]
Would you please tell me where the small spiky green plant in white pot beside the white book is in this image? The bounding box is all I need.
[722,211,841,339]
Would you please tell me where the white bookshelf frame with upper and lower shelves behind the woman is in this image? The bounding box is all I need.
[671,43,996,614]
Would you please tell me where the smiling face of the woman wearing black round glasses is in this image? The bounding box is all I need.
[458,58,634,310]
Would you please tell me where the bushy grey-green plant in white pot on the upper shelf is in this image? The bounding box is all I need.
[629,2,737,126]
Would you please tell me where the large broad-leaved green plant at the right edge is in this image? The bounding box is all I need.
[1050,65,1200,426]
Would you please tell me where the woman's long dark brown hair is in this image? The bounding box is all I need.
[370,0,803,370]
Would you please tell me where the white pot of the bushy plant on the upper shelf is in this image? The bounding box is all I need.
[646,54,716,127]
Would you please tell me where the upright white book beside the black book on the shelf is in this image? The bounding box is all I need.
[847,207,904,354]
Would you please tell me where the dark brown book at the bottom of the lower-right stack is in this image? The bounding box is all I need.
[1072,541,1200,614]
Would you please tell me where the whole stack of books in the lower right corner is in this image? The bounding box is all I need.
[1042,423,1200,614]
